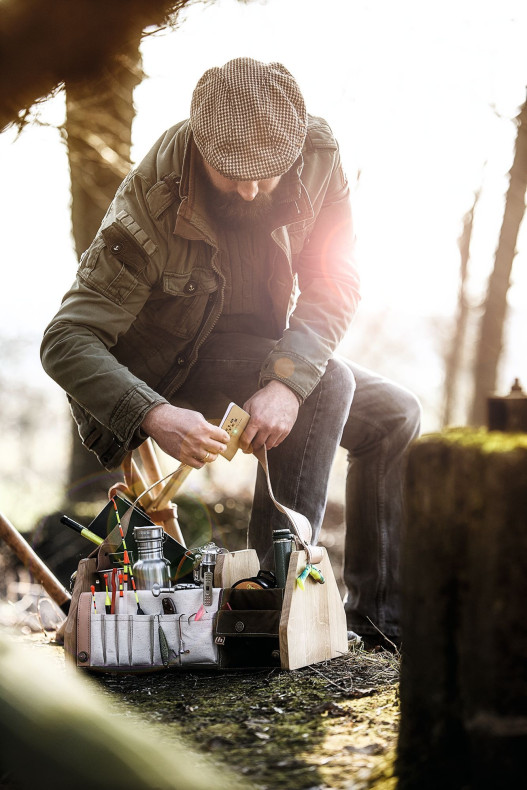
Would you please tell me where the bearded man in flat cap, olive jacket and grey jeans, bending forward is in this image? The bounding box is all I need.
[42,58,419,640]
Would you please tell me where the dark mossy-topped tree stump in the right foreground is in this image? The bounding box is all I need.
[397,429,527,790]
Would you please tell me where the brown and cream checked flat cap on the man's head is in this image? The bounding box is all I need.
[190,58,307,181]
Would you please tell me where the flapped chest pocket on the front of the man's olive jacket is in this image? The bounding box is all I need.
[149,267,218,339]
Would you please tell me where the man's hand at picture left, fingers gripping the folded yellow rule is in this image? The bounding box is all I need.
[141,403,229,469]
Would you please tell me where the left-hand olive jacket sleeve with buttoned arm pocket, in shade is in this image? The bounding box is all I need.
[41,175,166,447]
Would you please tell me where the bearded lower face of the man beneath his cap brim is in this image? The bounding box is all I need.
[201,158,282,227]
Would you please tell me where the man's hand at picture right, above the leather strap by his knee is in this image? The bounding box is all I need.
[240,379,300,453]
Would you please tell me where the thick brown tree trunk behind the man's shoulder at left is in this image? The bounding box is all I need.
[65,34,142,501]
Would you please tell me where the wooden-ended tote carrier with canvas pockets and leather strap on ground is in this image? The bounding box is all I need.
[64,448,348,672]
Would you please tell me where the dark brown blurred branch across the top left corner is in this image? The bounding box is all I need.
[0,0,197,130]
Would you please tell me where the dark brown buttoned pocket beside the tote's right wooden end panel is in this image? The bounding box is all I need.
[215,589,283,669]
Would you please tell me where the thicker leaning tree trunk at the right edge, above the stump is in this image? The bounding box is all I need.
[471,97,527,425]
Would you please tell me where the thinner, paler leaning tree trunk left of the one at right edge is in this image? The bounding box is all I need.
[442,190,480,425]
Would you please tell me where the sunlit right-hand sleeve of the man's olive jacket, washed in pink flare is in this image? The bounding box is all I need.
[260,144,360,402]
